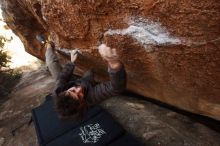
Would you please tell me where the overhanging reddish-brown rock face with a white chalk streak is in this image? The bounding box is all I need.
[1,0,220,120]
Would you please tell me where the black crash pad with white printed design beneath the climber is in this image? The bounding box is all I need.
[32,95,141,146]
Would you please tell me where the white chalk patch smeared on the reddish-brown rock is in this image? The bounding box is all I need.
[105,18,181,52]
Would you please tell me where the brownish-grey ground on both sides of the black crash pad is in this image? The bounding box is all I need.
[0,67,220,146]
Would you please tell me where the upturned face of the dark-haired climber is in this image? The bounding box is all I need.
[65,86,84,100]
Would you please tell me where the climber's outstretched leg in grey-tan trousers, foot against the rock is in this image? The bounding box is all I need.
[45,44,62,80]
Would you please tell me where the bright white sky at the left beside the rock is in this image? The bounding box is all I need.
[0,9,37,68]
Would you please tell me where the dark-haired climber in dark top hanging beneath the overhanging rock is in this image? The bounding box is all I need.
[45,42,126,121]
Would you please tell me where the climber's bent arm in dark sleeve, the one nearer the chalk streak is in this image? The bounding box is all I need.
[87,44,126,105]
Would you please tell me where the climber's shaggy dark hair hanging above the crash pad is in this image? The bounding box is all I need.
[55,92,87,121]
